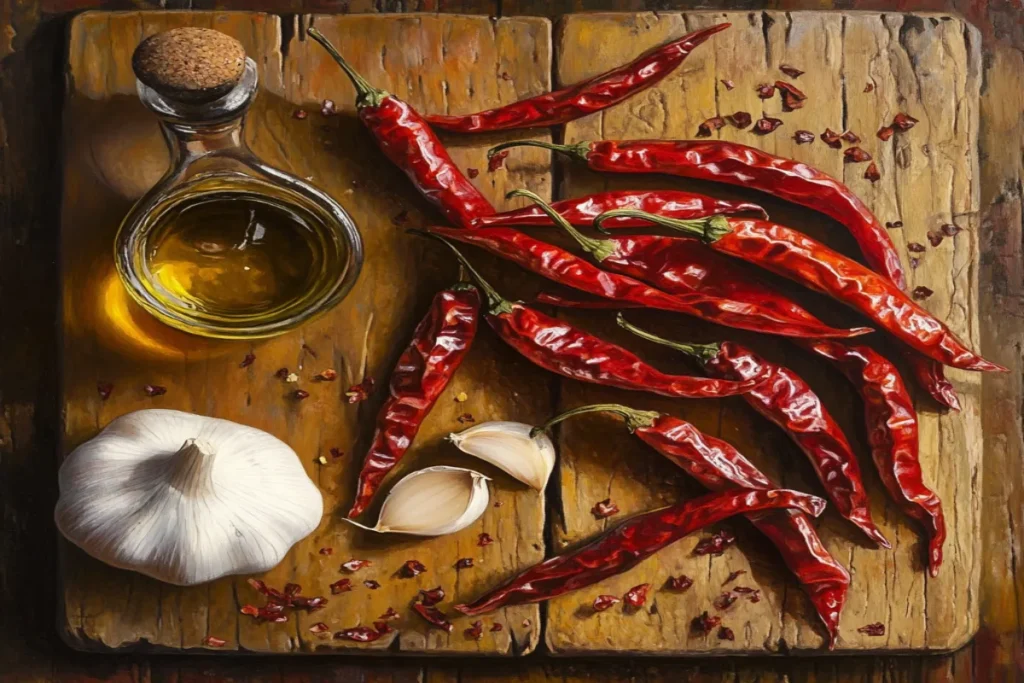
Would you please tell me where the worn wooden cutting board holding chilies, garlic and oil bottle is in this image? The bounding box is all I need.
[60,6,981,654]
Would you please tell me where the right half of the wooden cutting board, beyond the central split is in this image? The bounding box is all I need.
[546,12,982,654]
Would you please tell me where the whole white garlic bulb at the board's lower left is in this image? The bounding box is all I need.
[54,410,324,586]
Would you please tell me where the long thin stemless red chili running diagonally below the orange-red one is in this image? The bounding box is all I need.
[427,189,860,337]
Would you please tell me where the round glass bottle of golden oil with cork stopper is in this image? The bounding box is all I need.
[115,28,362,339]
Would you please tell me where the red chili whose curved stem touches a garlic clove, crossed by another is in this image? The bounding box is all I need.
[541,404,850,648]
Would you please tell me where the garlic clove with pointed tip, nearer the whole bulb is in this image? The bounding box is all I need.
[348,465,490,536]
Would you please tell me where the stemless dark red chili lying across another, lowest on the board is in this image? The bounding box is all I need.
[455,488,824,616]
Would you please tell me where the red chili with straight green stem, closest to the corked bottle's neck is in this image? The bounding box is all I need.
[307,27,495,227]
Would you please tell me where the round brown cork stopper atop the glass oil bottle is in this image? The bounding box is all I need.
[132,28,246,102]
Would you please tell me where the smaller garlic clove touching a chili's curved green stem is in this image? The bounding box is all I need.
[449,422,555,490]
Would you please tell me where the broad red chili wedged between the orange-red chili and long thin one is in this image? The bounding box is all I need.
[548,206,871,337]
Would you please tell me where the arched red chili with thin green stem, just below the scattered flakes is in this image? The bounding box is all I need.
[488,135,906,289]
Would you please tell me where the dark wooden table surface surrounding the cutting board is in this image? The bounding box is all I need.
[0,0,1024,683]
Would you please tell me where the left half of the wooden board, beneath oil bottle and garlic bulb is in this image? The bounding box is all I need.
[61,12,550,654]
